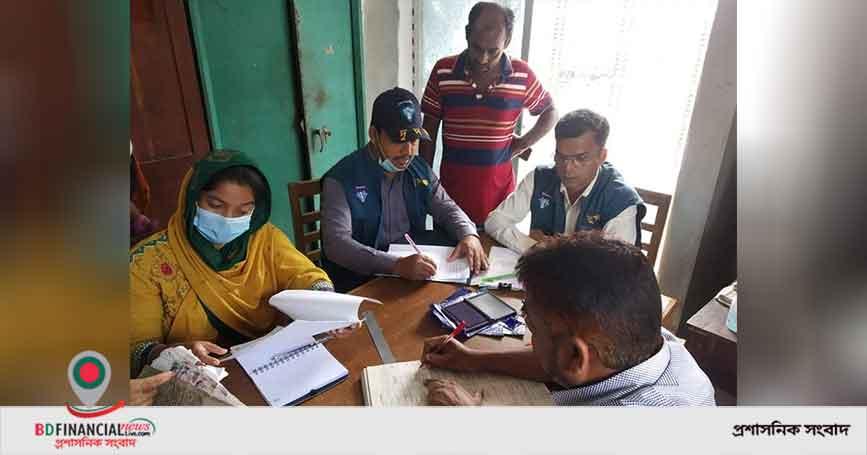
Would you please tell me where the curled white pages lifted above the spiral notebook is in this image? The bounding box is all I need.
[268,290,382,325]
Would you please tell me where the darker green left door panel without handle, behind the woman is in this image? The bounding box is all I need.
[188,0,308,239]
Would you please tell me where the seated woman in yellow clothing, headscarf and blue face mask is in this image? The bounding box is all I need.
[130,150,345,377]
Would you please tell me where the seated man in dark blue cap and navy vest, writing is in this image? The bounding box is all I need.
[322,87,488,291]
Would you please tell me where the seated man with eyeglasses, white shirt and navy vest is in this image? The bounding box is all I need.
[485,109,646,253]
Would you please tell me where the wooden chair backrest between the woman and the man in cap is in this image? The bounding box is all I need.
[289,179,322,264]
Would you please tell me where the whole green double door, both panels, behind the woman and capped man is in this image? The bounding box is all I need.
[187,0,366,238]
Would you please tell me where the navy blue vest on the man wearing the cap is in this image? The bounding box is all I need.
[323,147,432,252]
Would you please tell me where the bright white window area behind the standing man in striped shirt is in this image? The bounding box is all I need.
[414,0,717,239]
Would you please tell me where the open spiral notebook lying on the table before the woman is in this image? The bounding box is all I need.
[236,337,349,406]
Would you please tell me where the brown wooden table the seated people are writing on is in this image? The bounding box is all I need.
[223,234,677,406]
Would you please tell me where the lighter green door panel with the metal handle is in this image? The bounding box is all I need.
[292,0,367,178]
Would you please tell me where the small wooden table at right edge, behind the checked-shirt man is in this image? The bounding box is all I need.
[686,299,738,397]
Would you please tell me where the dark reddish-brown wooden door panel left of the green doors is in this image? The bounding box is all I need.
[130,0,210,228]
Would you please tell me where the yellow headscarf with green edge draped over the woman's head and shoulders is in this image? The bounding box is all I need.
[167,151,330,339]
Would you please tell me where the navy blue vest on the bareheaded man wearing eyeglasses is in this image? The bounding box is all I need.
[530,161,647,247]
